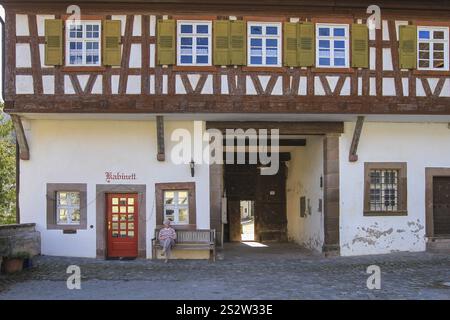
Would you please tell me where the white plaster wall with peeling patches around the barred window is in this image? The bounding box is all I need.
[340,122,450,256]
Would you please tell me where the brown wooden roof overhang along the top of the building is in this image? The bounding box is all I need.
[0,0,450,19]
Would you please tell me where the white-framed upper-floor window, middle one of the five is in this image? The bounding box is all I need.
[247,22,281,67]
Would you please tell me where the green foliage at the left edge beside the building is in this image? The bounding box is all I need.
[0,105,16,224]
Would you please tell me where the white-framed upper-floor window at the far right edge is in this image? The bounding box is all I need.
[417,27,449,70]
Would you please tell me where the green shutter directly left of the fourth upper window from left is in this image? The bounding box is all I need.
[297,22,315,67]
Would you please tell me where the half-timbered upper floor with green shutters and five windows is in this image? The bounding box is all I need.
[1,0,450,114]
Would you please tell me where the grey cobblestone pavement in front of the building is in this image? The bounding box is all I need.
[0,244,450,300]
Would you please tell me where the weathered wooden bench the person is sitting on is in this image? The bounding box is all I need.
[152,229,216,261]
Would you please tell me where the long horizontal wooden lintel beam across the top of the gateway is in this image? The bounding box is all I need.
[206,121,344,135]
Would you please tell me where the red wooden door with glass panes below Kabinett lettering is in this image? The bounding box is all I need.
[106,194,138,258]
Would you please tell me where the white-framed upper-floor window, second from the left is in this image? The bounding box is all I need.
[177,21,211,66]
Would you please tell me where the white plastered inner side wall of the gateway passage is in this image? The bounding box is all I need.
[286,136,324,252]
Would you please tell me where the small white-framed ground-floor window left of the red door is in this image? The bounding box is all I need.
[56,191,81,225]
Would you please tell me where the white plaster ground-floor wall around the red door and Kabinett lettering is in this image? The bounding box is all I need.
[20,120,210,257]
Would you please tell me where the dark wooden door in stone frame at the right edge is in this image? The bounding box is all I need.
[433,177,450,237]
